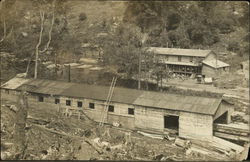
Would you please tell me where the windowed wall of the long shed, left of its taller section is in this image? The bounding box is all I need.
[25,95,134,129]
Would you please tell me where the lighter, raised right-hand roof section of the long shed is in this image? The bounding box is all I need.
[133,91,221,115]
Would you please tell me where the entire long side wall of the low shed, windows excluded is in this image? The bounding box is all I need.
[0,88,216,139]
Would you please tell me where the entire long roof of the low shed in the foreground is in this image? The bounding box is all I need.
[2,78,221,115]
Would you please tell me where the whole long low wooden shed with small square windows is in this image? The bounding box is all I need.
[1,77,233,139]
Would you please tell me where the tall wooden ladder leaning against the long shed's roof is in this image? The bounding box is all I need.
[99,77,117,126]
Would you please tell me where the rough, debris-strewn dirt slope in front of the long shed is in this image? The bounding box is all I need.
[1,97,231,161]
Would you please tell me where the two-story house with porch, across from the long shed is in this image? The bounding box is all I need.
[148,47,229,77]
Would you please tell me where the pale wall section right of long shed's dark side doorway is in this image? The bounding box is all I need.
[179,112,213,139]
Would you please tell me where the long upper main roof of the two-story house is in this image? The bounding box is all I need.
[148,47,212,57]
